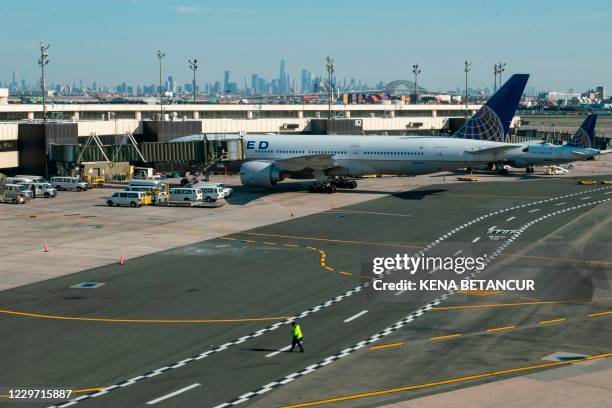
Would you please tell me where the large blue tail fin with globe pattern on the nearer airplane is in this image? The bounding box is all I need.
[453,74,529,142]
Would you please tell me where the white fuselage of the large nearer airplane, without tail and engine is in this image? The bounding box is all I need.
[244,135,516,177]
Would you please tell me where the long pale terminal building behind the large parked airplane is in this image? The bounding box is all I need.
[0,103,518,176]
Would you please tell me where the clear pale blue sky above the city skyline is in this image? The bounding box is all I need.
[0,0,612,90]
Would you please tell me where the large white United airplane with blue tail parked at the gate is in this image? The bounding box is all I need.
[240,74,529,193]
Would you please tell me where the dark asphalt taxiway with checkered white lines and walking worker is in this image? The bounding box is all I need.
[0,179,612,407]
